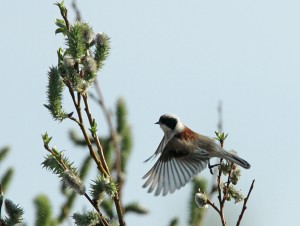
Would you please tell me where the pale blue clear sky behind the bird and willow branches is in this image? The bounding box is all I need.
[0,0,300,226]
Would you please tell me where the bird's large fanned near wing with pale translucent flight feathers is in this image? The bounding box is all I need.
[143,137,210,196]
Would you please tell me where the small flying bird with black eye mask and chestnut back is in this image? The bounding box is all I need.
[143,114,250,196]
